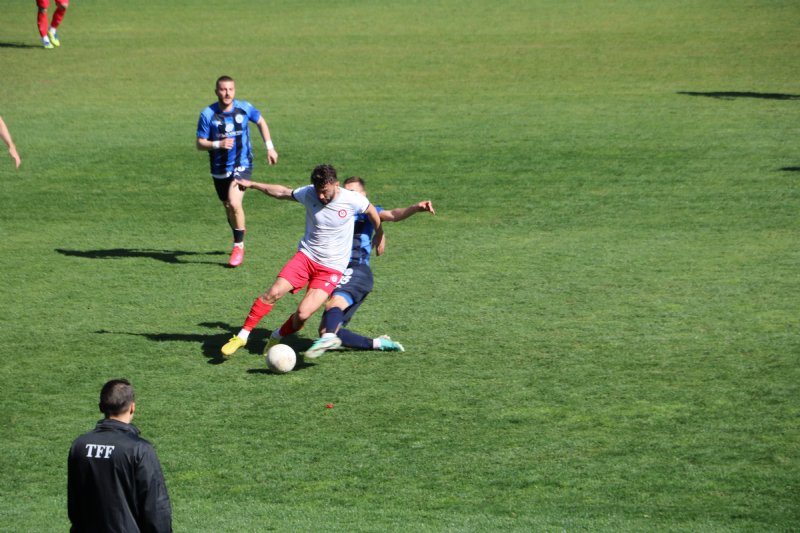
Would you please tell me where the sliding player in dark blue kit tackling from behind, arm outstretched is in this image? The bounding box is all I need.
[306,176,436,357]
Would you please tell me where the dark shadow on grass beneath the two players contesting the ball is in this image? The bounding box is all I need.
[95,322,314,374]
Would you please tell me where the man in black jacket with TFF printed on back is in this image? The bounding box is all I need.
[67,379,172,533]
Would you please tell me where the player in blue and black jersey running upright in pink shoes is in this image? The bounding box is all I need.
[197,76,278,267]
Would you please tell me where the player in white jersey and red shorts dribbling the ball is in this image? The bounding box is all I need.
[217,165,383,357]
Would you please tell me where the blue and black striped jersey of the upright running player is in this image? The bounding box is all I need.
[197,100,261,178]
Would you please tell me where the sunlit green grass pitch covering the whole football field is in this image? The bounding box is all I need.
[0,0,800,532]
